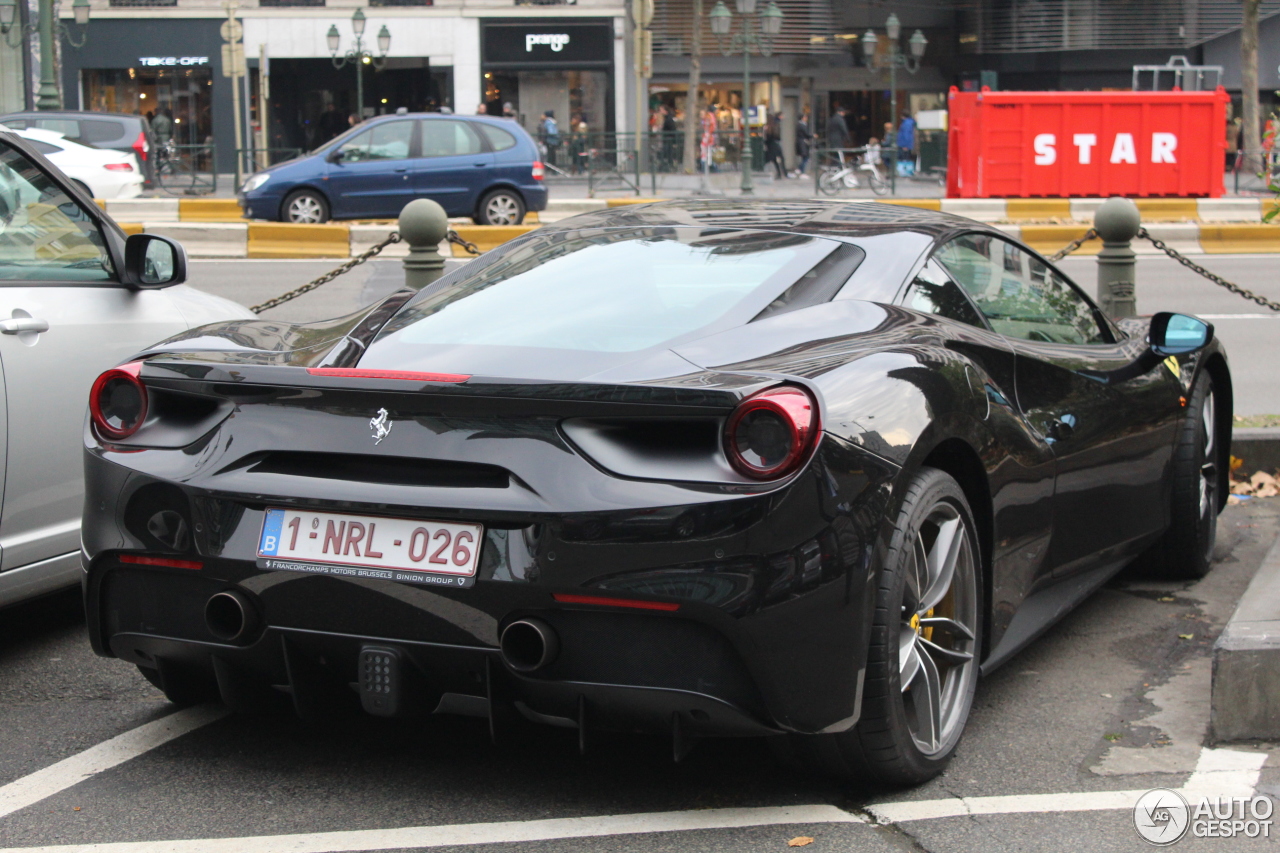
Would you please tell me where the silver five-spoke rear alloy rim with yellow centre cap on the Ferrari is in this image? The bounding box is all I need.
[899,501,978,756]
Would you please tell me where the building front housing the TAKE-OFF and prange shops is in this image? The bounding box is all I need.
[47,0,630,172]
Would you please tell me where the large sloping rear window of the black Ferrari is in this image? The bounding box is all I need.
[378,228,860,356]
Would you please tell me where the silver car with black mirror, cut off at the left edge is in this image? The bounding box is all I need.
[0,132,252,605]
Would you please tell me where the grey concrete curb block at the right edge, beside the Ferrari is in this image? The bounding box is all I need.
[1210,527,1280,743]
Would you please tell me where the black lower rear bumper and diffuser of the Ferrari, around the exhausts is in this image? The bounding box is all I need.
[86,566,782,736]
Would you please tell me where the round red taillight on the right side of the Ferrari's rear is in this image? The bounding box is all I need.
[724,386,818,480]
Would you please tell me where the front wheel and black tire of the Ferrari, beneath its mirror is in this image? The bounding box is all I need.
[1139,370,1224,580]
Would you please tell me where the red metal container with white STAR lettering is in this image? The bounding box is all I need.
[947,87,1229,199]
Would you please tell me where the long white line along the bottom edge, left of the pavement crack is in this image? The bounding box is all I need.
[0,806,865,853]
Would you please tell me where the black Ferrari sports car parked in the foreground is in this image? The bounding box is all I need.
[83,201,1231,785]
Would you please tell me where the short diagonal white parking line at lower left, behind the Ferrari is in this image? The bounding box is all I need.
[0,704,228,817]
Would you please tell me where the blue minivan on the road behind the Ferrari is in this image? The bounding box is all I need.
[239,113,547,225]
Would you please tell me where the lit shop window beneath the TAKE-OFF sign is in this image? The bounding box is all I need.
[83,65,214,145]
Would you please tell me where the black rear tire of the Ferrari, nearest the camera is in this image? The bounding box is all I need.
[774,467,984,789]
